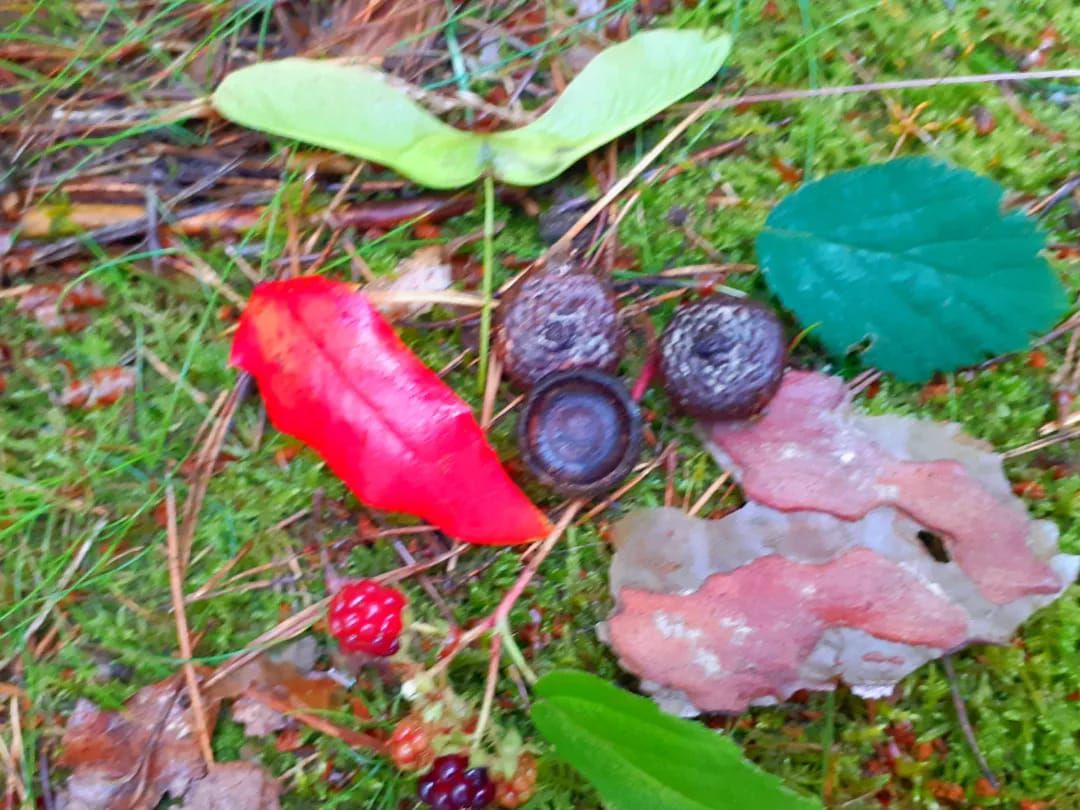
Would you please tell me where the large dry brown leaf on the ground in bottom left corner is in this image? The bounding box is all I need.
[57,677,218,810]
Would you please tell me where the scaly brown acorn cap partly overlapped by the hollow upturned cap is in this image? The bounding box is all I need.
[495,262,622,389]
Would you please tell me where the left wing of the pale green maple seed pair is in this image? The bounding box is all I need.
[213,58,483,188]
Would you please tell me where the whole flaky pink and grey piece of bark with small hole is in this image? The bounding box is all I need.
[602,373,1080,714]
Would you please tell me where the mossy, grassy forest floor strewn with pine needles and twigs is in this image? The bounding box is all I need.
[0,0,1080,810]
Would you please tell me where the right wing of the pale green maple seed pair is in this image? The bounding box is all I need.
[489,28,731,186]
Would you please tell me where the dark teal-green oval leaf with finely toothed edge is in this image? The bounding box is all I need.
[757,158,1067,380]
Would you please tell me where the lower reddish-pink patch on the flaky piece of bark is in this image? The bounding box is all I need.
[607,549,968,712]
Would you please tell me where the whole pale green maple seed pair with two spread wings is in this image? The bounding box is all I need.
[212,29,731,188]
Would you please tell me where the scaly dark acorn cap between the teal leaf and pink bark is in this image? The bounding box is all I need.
[660,295,787,420]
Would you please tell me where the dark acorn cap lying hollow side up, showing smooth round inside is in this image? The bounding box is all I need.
[517,368,642,498]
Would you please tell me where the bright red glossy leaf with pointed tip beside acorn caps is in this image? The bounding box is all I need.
[231,275,549,544]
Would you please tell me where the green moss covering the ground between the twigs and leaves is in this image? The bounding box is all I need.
[0,0,1080,810]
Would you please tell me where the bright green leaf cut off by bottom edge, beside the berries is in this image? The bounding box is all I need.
[531,672,820,810]
